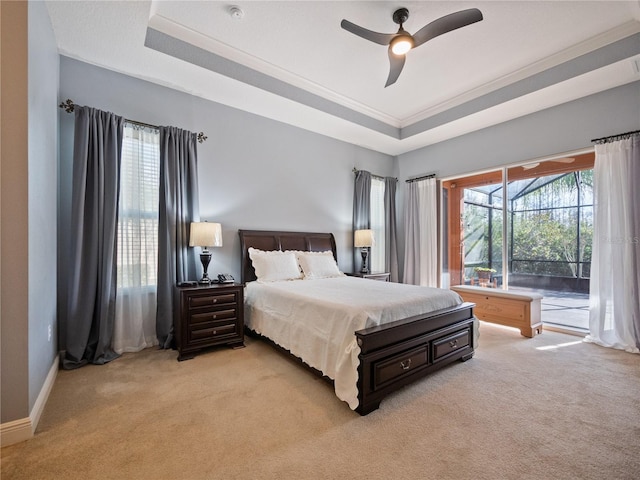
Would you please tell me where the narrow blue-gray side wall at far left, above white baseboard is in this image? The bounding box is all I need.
[28,2,60,411]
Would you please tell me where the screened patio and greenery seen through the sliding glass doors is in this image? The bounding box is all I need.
[463,170,593,333]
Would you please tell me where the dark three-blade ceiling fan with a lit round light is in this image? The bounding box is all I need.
[340,8,482,88]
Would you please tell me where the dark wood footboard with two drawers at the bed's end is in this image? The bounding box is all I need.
[356,303,475,415]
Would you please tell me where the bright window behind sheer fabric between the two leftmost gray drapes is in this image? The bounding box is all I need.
[117,122,160,289]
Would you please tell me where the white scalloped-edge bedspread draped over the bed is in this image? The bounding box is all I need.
[245,276,462,409]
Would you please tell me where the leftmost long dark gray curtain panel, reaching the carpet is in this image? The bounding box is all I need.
[62,107,124,369]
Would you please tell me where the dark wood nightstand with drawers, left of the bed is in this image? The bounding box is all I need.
[173,283,244,360]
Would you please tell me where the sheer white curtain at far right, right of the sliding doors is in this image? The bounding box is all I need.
[585,134,640,353]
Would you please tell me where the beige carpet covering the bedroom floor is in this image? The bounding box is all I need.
[1,323,640,480]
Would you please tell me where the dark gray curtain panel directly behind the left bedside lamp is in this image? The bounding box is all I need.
[156,127,199,348]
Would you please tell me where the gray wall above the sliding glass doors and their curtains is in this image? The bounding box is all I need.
[398,81,640,280]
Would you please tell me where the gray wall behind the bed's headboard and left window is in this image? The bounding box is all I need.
[58,57,395,348]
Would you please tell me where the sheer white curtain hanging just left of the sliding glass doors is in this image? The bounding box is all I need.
[404,178,438,287]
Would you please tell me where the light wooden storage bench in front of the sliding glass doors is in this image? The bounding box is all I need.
[450,285,542,338]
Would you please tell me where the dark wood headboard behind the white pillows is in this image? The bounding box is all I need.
[238,230,338,283]
